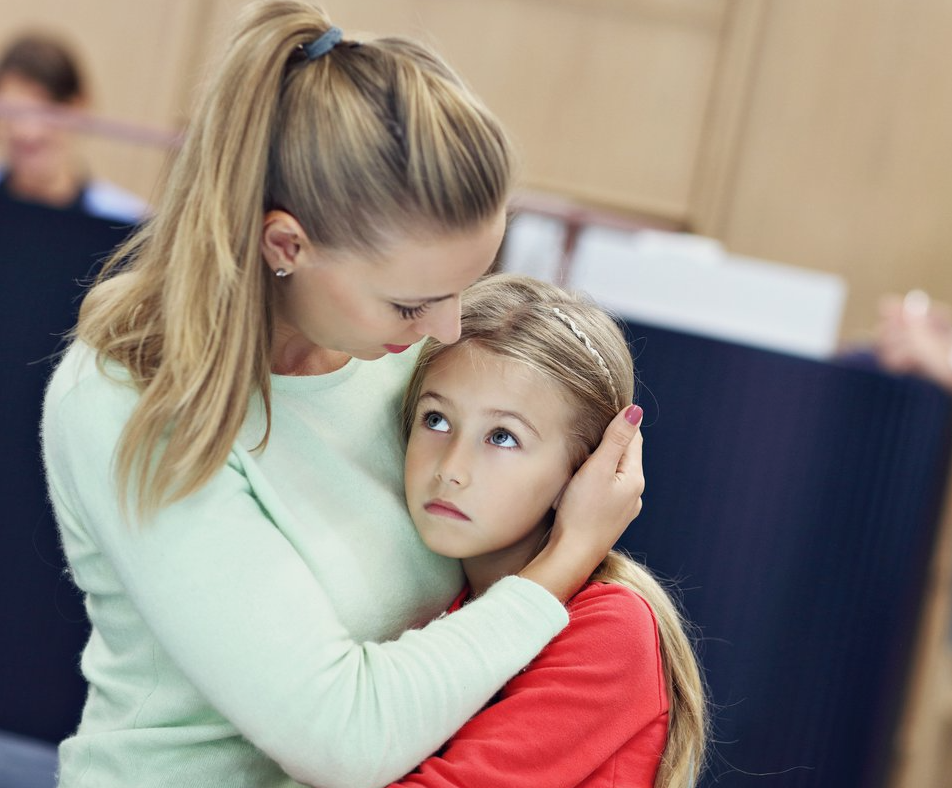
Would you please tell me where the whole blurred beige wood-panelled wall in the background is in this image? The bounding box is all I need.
[0,0,952,788]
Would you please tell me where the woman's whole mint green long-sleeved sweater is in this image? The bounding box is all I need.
[43,344,567,788]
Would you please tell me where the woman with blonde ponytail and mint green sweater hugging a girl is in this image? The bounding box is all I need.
[43,0,643,788]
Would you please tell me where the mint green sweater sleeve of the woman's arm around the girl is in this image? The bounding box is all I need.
[43,360,567,788]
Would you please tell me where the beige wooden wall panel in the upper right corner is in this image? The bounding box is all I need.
[701,0,952,338]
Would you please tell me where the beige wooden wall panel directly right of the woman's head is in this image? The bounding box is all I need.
[292,0,727,221]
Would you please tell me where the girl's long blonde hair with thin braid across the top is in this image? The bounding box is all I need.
[403,274,708,788]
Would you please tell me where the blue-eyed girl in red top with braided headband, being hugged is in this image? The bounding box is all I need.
[399,275,705,788]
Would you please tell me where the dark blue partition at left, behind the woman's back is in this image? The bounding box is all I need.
[0,198,129,741]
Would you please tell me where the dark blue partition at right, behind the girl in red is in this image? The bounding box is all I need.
[622,324,952,788]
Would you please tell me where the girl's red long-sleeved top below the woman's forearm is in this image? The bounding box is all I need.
[390,584,668,788]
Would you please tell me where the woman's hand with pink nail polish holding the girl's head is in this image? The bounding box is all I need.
[519,405,645,602]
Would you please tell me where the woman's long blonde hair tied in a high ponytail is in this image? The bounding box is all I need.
[76,0,511,515]
